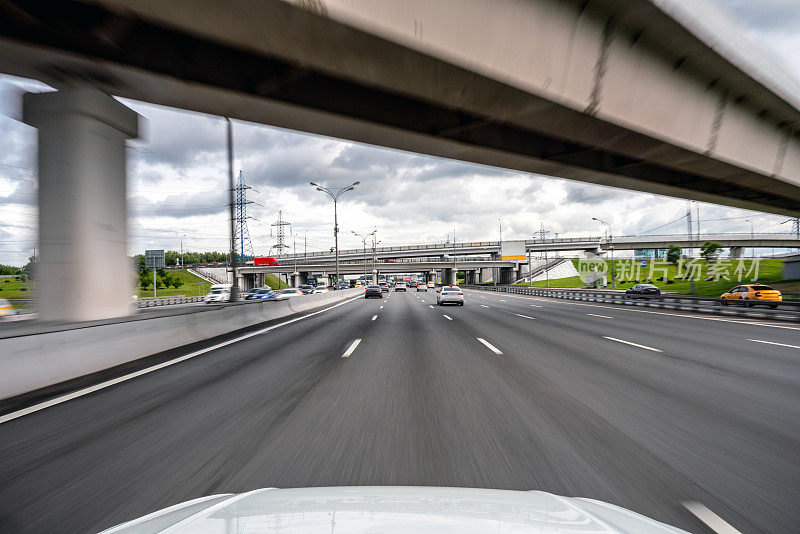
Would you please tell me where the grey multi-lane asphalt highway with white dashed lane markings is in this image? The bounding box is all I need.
[0,291,800,533]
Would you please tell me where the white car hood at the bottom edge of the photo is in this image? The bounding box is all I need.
[103,486,684,534]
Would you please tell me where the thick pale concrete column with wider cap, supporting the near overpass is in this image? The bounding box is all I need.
[23,88,139,321]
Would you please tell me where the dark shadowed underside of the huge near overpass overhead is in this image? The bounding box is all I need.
[0,0,800,215]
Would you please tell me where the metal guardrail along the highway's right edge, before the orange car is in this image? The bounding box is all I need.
[461,285,800,322]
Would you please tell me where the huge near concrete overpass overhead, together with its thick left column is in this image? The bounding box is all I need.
[0,0,800,320]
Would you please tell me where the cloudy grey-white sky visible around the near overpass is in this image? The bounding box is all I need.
[0,0,800,265]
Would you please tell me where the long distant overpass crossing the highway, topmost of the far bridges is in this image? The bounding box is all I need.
[278,233,800,263]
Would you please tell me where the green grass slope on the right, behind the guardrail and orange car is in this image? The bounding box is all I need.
[520,258,800,297]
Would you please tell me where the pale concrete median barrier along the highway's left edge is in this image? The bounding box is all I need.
[0,289,361,400]
